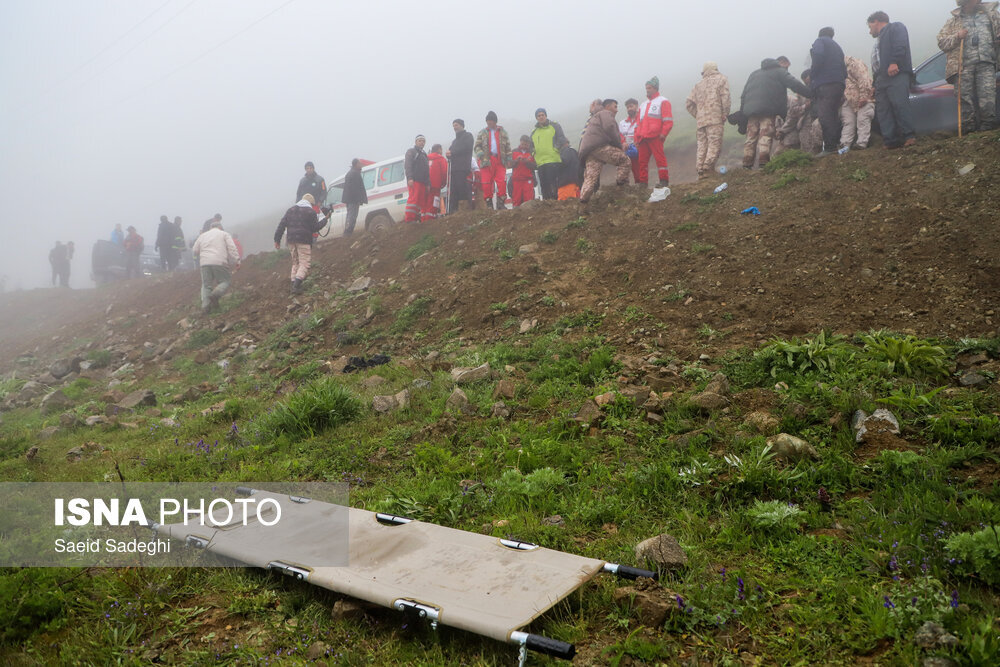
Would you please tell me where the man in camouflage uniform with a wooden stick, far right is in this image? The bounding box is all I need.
[938,0,1000,132]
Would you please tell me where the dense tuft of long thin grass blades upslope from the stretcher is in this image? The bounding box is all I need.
[263,378,361,437]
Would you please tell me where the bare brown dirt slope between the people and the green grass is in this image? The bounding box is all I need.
[0,135,1000,373]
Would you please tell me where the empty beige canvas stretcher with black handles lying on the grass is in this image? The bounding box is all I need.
[152,487,656,665]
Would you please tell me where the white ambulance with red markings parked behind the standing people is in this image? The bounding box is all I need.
[322,155,407,236]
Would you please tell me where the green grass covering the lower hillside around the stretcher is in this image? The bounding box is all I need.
[0,328,1000,665]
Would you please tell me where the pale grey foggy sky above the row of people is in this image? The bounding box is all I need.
[0,0,954,290]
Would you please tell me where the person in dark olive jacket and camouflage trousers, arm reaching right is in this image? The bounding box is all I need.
[740,58,813,169]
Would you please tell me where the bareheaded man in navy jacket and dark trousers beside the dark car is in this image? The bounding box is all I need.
[868,12,917,148]
